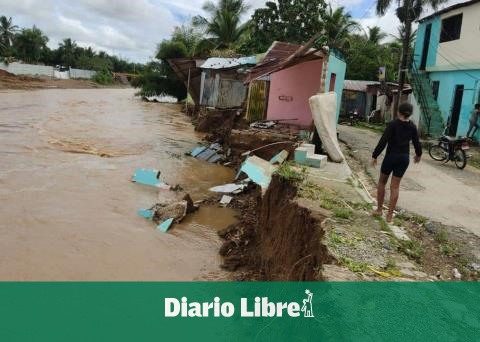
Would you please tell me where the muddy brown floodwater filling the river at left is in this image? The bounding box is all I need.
[0,89,235,281]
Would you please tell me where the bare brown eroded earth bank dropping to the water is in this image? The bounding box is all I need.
[220,175,329,281]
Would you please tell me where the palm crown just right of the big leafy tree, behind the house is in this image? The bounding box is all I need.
[323,5,360,51]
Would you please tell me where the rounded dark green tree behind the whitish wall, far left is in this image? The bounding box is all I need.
[14,26,48,63]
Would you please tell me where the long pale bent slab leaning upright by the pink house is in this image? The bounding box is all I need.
[309,92,345,163]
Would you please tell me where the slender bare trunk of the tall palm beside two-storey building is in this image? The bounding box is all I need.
[392,0,413,118]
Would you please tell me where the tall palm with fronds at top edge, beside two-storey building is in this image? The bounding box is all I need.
[377,0,448,113]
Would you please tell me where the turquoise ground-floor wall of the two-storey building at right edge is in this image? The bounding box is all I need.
[429,70,480,139]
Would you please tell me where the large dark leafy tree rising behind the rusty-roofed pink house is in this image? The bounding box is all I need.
[240,0,327,54]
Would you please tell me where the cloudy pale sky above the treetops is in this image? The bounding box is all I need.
[0,0,462,62]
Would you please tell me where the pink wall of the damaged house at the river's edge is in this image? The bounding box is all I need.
[267,60,322,127]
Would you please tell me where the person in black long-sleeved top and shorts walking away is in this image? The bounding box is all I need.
[372,103,422,223]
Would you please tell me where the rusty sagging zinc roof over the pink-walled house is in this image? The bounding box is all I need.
[245,39,325,83]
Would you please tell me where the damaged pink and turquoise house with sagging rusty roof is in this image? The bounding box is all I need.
[246,42,346,127]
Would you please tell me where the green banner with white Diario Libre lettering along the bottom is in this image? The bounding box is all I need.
[0,283,480,342]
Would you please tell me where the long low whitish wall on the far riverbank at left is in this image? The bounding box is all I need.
[0,62,95,79]
